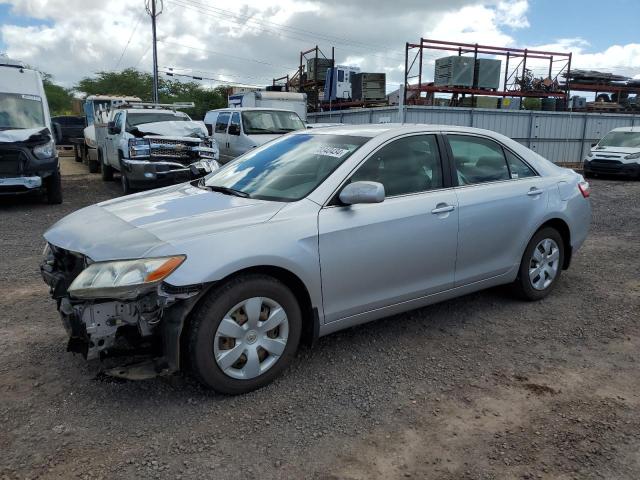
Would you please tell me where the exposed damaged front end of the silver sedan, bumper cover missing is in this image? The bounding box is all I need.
[40,246,207,379]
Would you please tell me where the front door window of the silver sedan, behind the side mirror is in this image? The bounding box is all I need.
[351,135,443,197]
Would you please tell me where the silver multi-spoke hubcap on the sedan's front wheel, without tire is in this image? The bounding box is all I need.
[213,297,289,380]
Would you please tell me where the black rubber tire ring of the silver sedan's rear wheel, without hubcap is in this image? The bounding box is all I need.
[513,227,564,301]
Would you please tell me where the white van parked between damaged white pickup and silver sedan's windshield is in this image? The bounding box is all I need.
[204,107,305,163]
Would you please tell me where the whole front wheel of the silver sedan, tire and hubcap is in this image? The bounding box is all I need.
[188,275,302,395]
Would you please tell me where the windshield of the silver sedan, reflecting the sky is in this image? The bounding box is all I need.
[204,134,369,202]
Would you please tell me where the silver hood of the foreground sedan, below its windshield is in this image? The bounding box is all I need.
[44,183,285,261]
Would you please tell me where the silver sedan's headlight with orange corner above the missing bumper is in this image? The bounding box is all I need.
[69,255,186,299]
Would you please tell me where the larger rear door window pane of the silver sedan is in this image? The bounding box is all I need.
[447,135,509,185]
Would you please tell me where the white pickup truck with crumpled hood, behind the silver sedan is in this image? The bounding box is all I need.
[96,103,220,194]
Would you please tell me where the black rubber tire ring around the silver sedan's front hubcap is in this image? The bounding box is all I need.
[187,274,302,395]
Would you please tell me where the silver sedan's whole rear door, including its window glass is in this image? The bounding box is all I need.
[447,134,549,286]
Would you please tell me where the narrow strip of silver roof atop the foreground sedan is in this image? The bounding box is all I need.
[294,123,510,138]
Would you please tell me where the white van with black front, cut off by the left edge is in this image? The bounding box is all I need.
[0,57,62,203]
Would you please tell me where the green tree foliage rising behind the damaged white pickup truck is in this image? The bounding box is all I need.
[75,68,227,120]
